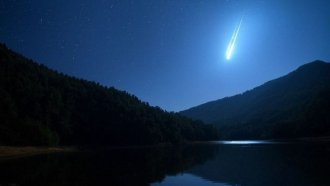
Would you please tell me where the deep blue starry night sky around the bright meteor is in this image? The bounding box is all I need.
[0,0,330,111]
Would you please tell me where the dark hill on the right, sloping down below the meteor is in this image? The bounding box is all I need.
[181,61,330,139]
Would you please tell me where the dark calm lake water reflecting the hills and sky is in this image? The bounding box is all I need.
[0,142,330,186]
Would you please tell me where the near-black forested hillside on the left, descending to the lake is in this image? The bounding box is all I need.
[0,44,218,145]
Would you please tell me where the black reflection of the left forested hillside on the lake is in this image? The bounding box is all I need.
[0,145,216,186]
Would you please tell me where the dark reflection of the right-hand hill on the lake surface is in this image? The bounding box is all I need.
[188,143,330,186]
